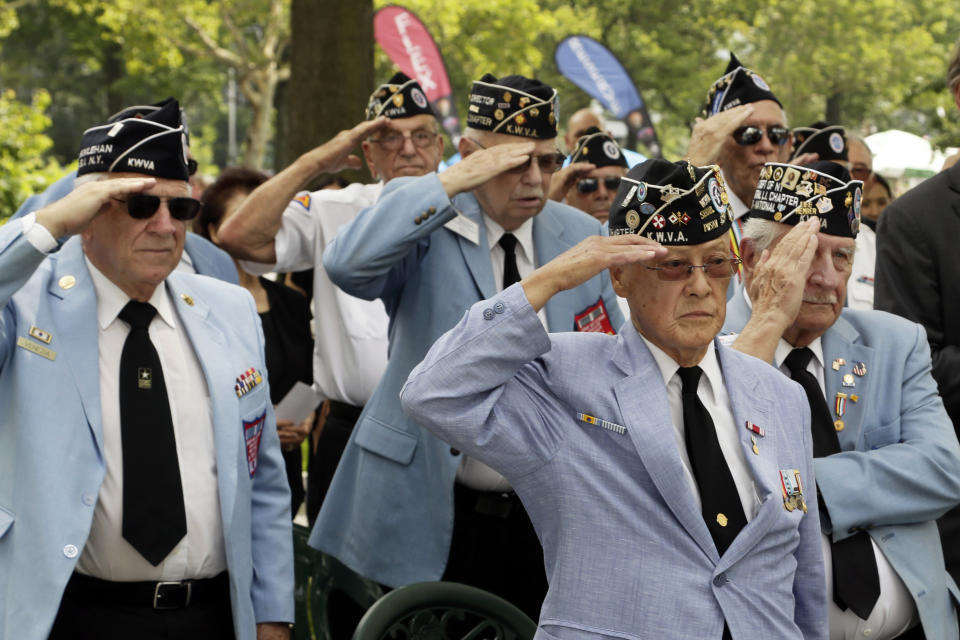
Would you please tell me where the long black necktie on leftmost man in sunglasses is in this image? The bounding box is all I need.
[120,300,187,566]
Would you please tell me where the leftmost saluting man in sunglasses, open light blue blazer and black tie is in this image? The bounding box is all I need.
[0,101,293,640]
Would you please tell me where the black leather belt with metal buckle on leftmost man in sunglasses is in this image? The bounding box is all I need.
[66,571,230,610]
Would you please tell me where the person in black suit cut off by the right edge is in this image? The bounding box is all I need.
[874,37,960,582]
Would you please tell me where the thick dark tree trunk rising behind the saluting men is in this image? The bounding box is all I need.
[276,0,374,181]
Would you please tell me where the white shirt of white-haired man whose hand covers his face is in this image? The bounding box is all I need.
[773,338,919,640]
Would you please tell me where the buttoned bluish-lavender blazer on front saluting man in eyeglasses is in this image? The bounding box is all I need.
[402,285,827,640]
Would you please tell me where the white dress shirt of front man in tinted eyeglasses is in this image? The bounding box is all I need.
[640,335,760,522]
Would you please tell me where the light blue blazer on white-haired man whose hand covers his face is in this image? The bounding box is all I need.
[724,291,960,640]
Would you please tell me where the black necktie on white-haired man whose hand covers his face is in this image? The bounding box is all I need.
[783,347,880,620]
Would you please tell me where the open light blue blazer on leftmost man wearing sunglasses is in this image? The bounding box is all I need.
[0,220,293,640]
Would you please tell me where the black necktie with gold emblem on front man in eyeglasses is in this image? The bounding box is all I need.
[677,367,747,555]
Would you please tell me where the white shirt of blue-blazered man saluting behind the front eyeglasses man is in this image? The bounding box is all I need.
[457,215,550,492]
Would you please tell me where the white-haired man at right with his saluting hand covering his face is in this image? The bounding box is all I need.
[725,162,960,640]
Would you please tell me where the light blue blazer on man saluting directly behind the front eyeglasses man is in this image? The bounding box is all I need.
[310,174,622,587]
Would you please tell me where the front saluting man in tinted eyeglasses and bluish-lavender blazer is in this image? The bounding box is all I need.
[402,160,826,640]
